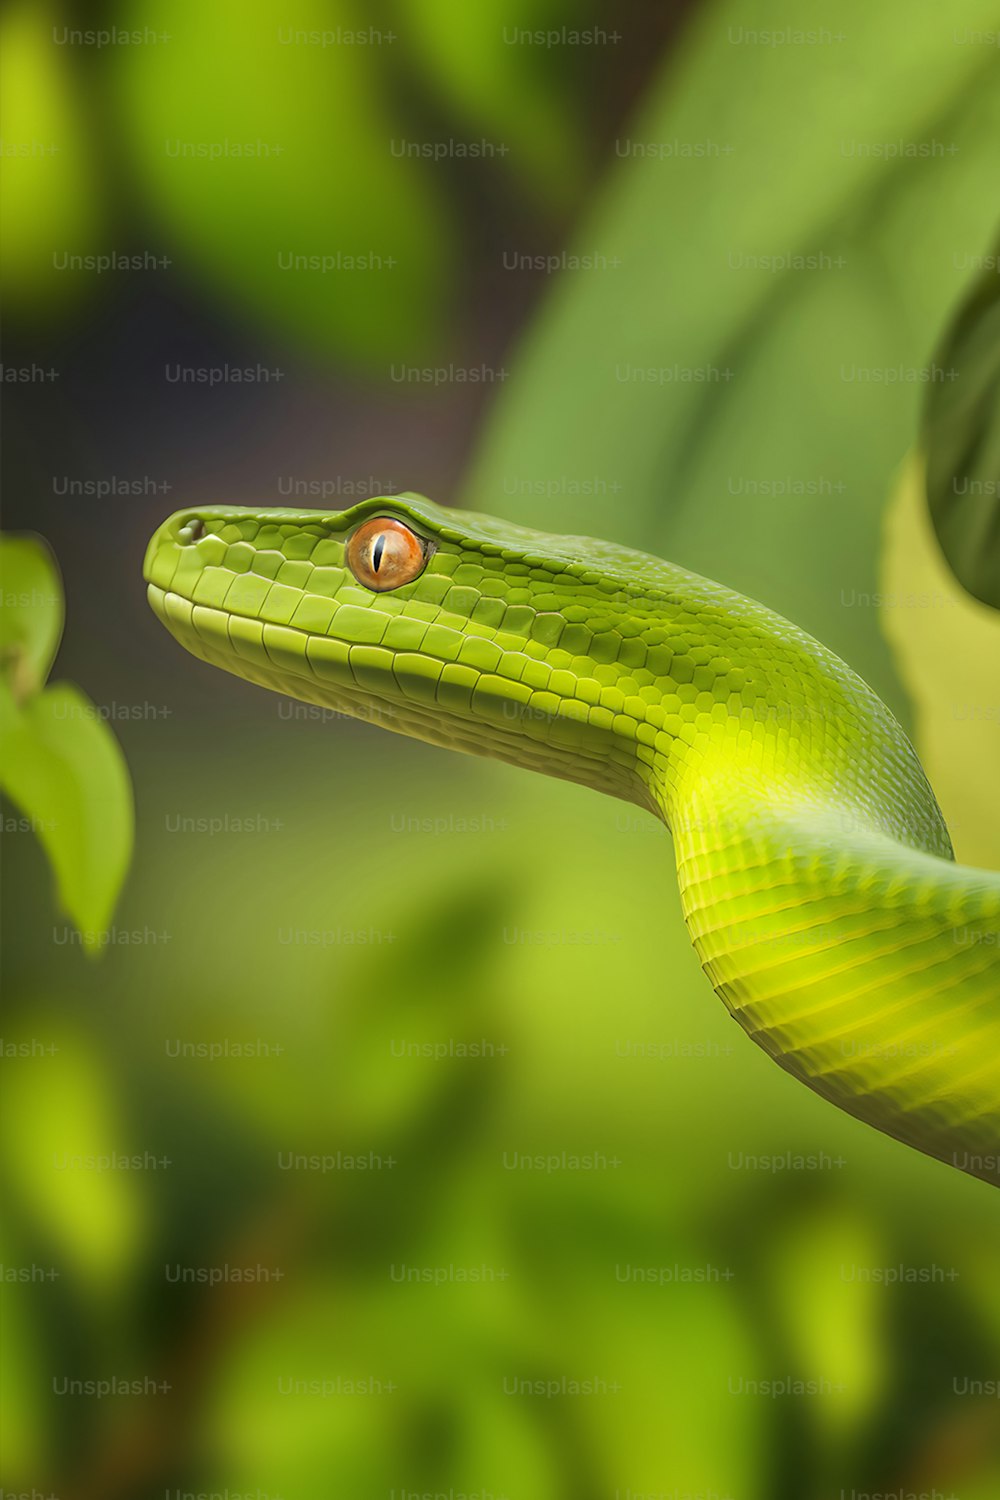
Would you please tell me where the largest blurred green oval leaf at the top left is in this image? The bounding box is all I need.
[117,0,451,366]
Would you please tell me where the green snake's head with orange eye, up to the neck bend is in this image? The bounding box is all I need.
[144,495,676,806]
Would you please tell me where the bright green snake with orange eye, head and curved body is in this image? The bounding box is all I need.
[144,495,1000,1185]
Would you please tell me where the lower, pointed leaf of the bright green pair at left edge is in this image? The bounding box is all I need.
[0,683,133,953]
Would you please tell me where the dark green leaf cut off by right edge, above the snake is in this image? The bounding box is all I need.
[924,255,1000,609]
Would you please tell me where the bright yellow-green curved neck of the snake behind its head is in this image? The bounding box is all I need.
[649,645,1000,1187]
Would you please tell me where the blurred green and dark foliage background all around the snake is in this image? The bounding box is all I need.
[0,0,1000,1500]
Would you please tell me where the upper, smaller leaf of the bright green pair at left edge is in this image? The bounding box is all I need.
[0,534,63,702]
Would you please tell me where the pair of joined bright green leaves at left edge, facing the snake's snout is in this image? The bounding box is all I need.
[0,536,132,953]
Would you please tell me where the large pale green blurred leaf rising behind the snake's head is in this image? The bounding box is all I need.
[459,0,1000,704]
